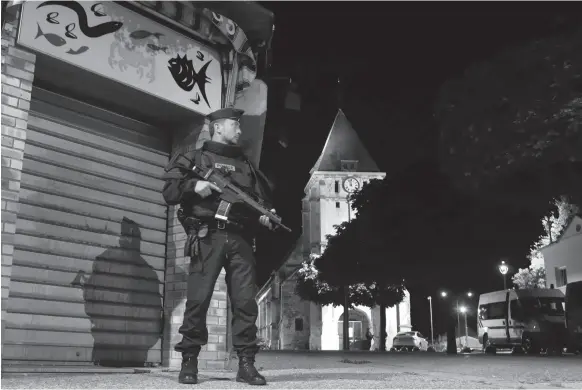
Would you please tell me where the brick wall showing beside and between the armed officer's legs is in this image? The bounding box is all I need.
[162,200,229,369]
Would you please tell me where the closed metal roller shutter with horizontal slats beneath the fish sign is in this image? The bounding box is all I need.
[2,90,170,365]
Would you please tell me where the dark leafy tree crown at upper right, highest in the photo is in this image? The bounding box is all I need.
[435,28,582,211]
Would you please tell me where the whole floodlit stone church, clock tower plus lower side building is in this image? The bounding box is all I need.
[257,109,411,350]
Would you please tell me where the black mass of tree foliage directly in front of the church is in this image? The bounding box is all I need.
[310,161,550,289]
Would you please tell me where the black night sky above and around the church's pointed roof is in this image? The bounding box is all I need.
[252,2,582,336]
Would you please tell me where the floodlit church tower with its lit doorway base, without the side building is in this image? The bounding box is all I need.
[302,109,411,350]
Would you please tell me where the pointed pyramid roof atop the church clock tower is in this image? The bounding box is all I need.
[310,109,380,174]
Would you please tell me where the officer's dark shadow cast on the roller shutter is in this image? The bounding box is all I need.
[72,217,162,367]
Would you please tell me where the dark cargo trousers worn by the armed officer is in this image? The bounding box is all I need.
[174,230,258,357]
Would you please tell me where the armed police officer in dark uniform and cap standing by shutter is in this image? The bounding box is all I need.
[163,108,274,385]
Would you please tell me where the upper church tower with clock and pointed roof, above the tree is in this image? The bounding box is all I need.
[303,109,386,256]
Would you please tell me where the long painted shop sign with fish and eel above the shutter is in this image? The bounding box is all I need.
[18,1,222,115]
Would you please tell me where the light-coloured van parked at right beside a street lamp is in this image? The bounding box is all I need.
[477,288,567,353]
